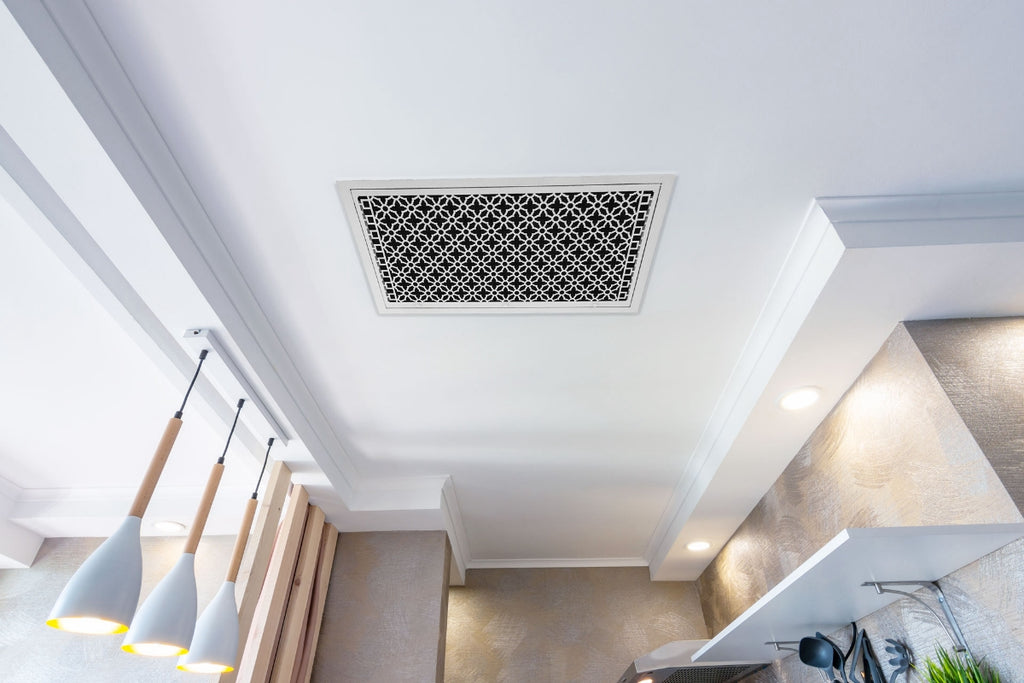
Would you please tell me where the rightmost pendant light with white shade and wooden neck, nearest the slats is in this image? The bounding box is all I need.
[178,436,273,674]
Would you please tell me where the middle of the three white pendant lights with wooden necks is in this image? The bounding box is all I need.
[121,398,246,656]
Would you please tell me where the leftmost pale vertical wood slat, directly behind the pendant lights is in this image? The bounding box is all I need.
[219,460,292,683]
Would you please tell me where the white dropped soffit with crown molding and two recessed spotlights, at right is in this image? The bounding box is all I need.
[648,193,1024,581]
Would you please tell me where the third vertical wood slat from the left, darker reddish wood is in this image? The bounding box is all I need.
[270,506,324,683]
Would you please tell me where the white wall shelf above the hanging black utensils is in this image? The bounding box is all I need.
[693,523,1024,663]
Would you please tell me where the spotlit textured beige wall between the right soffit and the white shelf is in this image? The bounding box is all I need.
[698,326,1021,633]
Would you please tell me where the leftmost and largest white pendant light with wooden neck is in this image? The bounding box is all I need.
[46,349,207,634]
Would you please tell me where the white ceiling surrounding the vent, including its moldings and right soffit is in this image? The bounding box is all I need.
[0,0,1024,579]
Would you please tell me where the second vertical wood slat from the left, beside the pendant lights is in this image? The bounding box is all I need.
[238,484,309,683]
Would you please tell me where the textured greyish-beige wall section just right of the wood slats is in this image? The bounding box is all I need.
[313,531,451,683]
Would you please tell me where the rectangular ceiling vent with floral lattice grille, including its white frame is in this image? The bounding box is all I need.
[338,176,674,313]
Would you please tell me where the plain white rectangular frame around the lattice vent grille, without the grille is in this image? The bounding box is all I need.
[337,174,676,315]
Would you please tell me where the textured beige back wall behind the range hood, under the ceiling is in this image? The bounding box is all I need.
[444,567,708,683]
